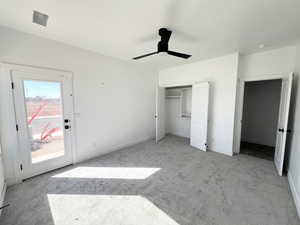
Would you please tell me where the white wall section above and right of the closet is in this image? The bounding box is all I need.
[159,53,238,155]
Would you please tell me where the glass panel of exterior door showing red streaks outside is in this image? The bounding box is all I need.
[23,80,65,163]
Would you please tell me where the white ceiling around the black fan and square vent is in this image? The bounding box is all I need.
[0,0,300,68]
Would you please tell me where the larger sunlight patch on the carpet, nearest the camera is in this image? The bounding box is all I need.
[47,194,179,225]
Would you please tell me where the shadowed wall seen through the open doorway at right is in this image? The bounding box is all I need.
[242,80,282,147]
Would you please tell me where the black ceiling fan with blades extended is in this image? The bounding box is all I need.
[133,28,191,60]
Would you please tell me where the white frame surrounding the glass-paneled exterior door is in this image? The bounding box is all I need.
[0,62,76,183]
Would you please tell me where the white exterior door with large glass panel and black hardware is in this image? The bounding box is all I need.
[11,70,73,179]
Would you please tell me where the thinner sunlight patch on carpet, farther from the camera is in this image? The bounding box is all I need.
[53,167,160,180]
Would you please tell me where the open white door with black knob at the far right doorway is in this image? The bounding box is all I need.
[274,73,293,176]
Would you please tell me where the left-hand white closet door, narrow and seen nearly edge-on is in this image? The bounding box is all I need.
[155,86,166,143]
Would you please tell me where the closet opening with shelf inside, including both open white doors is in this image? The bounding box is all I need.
[155,82,210,151]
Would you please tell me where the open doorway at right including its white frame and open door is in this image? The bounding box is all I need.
[235,73,294,176]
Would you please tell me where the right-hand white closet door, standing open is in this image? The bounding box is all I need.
[191,82,209,151]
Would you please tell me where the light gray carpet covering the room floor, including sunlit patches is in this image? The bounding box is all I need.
[0,136,300,225]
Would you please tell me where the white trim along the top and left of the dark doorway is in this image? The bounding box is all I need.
[233,73,289,154]
